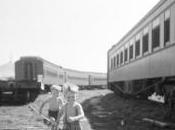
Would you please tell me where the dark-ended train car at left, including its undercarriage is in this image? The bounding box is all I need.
[15,57,64,99]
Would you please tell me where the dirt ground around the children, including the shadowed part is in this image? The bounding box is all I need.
[0,89,174,130]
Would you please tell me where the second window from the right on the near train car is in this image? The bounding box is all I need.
[152,18,160,49]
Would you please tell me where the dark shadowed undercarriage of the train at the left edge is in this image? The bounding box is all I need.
[0,81,40,103]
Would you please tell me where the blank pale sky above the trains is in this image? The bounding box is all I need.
[0,0,159,72]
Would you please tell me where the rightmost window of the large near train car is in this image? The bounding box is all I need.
[164,10,170,45]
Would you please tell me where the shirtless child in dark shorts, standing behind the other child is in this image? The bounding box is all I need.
[39,85,63,120]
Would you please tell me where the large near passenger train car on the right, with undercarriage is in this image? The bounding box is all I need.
[107,0,175,103]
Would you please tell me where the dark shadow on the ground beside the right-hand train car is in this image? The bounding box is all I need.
[82,93,174,130]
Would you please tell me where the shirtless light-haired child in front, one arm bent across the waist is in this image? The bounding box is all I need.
[55,84,84,130]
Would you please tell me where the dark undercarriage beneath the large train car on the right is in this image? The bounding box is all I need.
[108,77,175,116]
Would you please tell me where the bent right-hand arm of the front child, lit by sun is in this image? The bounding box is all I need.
[69,104,84,122]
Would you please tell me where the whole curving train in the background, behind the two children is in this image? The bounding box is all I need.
[0,56,107,102]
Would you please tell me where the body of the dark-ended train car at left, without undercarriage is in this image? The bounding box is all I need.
[15,57,64,85]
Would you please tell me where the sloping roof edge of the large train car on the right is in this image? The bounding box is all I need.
[108,0,167,53]
